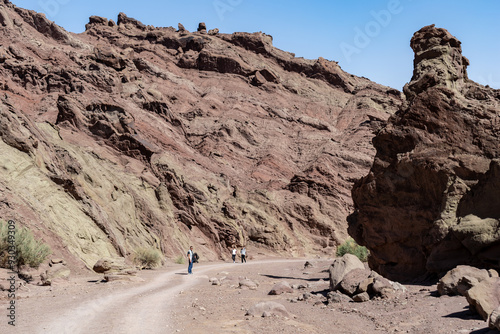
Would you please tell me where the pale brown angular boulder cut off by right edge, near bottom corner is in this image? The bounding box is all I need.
[465,277,500,320]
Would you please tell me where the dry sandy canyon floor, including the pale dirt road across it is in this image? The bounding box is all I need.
[0,259,498,334]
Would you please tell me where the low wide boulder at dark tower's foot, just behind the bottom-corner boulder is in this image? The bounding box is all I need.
[437,266,498,296]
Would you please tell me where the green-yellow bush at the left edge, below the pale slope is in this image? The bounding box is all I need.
[0,221,52,268]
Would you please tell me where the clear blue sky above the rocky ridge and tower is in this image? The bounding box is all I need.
[12,0,500,90]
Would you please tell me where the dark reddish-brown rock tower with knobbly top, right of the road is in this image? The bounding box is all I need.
[349,26,500,280]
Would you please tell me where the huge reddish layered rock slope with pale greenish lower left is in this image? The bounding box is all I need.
[0,1,402,268]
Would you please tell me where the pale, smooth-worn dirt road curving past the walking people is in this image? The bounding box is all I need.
[34,260,302,334]
